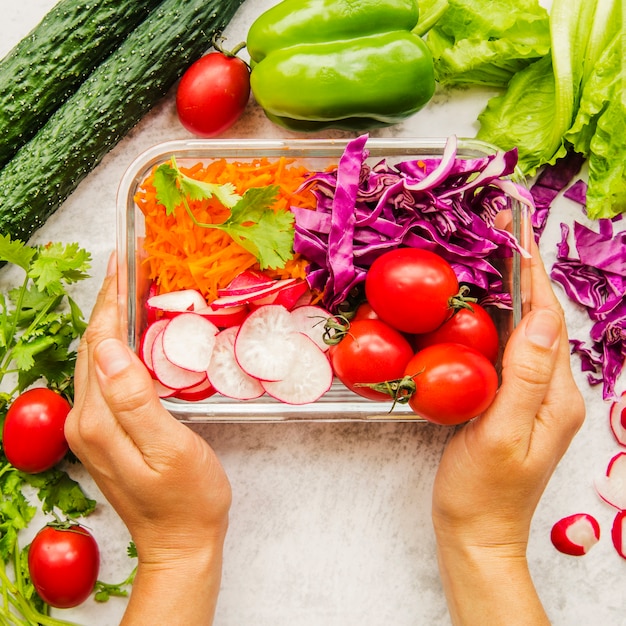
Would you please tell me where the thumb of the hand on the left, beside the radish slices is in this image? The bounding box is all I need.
[94,338,173,449]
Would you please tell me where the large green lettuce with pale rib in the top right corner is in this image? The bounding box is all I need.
[478,0,626,219]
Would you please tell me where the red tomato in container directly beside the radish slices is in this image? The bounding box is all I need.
[329,319,413,401]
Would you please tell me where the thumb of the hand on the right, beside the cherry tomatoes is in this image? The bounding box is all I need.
[494,308,564,426]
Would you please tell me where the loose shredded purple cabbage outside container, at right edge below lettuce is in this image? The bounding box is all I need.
[550,219,626,400]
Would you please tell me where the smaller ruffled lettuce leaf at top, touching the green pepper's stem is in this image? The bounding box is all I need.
[420,0,550,87]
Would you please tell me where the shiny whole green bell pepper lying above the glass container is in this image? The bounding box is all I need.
[247,0,435,131]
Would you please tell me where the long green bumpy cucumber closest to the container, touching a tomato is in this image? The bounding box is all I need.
[0,0,243,241]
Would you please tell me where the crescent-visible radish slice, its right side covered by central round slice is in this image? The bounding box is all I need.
[207,326,265,400]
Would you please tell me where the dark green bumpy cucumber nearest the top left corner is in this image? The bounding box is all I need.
[0,0,161,167]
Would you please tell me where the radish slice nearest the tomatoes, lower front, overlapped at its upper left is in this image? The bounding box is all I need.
[261,333,333,404]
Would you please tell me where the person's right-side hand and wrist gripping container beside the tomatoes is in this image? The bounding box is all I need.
[432,240,585,626]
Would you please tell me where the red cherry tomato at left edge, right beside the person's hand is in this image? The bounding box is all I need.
[2,387,71,474]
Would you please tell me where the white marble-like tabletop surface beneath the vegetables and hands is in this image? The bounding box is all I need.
[0,0,626,626]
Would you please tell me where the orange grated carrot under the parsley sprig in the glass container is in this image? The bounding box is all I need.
[135,157,315,302]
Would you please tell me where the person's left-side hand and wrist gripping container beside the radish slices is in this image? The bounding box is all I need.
[65,256,231,624]
